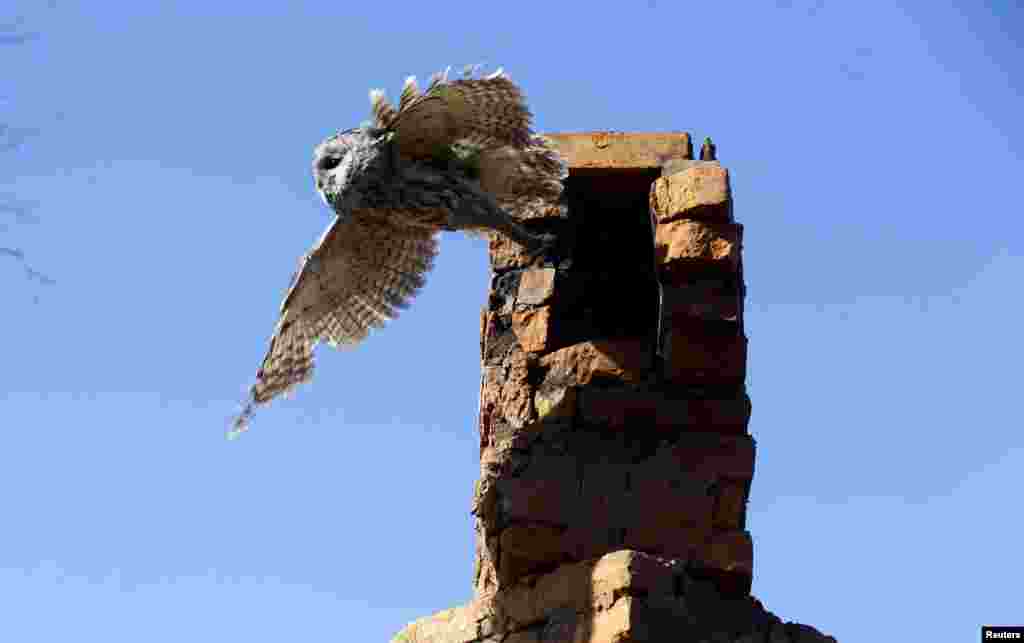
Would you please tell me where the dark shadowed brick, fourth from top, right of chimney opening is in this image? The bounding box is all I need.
[662,325,746,385]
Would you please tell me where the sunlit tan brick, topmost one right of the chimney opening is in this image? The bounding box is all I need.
[650,163,732,223]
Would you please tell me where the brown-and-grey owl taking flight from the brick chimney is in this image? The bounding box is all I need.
[230,68,567,436]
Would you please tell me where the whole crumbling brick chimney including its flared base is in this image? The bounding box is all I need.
[394,132,834,643]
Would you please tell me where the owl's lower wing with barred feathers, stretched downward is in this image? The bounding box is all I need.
[234,213,437,431]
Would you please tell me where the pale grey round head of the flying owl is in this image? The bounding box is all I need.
[313,127,390,216]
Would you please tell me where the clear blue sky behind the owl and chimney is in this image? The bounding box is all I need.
[0,0,1024,643]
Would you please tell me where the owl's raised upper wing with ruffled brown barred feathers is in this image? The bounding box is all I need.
[370,68,531,158]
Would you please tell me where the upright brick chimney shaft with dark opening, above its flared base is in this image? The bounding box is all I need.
[474,134,754,594]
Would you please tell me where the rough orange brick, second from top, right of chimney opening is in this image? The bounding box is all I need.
[654,219,743,284]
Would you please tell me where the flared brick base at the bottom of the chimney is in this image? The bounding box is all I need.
[392,550,836,643]
